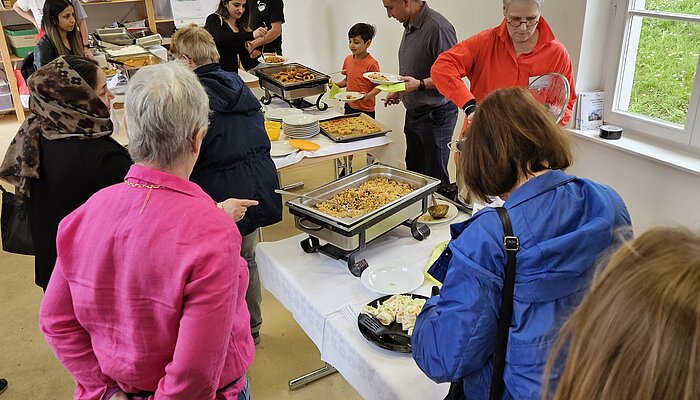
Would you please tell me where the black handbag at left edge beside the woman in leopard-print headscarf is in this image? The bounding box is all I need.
[0,186,34,256]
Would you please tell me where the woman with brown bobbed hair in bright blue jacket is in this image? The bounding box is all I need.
[413,88,631,400]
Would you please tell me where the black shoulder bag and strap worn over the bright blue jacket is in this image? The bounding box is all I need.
[445,207,520,400]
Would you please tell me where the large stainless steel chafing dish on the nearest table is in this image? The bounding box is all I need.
[285,163,440,276]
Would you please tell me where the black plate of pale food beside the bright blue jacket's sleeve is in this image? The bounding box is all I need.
[357,294,428,353]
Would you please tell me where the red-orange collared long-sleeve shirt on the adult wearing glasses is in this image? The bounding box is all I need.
[430,18,576,127]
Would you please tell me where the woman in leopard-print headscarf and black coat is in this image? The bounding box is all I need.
[0,55,131,290]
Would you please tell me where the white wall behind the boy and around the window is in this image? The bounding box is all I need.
[284,0,700,233]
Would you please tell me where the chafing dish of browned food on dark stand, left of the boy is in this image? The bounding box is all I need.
[255,63,331,110]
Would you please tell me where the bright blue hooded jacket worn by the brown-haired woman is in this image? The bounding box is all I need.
[412,170,631,400]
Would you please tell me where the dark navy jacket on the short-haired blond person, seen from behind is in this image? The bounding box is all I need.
[190,64,282,235]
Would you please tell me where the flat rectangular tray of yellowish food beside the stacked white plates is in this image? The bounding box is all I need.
[320,113,391,143]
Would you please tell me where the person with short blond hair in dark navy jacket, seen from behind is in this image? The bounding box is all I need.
[170,25,282,344]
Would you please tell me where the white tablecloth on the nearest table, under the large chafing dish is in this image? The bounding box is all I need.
[256,214,467,400]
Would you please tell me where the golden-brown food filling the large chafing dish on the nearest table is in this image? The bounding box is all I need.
[314,178,413,218]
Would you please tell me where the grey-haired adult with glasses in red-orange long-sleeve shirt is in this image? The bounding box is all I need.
[430,0,576,128]
